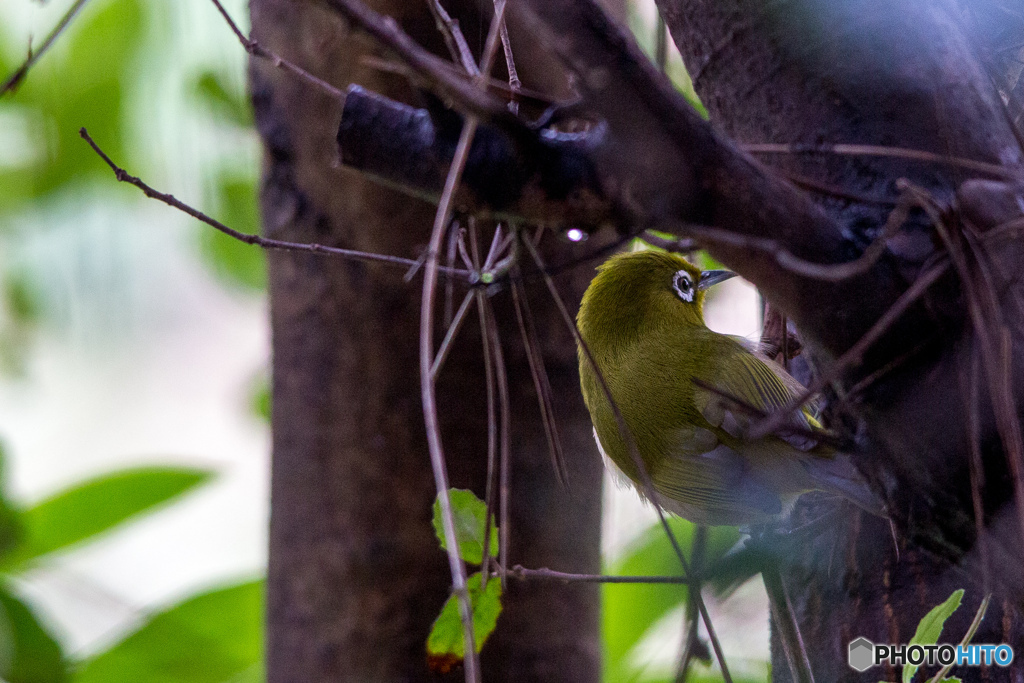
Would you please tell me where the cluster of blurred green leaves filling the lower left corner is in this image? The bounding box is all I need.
[0,438,263,683]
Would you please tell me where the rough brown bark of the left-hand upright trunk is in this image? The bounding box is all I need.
[251,0,600,683]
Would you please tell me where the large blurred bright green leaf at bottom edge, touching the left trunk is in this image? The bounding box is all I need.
[72,581,264,683]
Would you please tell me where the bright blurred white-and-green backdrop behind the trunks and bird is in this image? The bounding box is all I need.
[0,0,768,683]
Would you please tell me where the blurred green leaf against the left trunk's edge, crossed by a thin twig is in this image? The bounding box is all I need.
[199,174,266,290]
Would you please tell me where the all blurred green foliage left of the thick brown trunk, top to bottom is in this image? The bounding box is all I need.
[0,0,269,683]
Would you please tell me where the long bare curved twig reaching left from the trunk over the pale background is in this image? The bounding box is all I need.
[79,128,472,282]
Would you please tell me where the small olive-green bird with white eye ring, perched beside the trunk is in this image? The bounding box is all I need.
[577,251,886,525]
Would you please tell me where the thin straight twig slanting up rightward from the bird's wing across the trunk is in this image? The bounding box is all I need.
[748,259,949,439]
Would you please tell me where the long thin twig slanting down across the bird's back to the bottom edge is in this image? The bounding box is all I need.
[522,240,732,683]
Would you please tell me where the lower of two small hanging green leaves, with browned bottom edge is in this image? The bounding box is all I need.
[427,571,502,673]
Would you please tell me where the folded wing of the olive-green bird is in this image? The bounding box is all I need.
[693,335,820,451]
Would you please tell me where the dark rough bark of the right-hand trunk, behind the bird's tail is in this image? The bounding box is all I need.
[659,0,1022,681]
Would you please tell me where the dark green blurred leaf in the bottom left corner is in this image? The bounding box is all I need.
[0,587,68,683]
